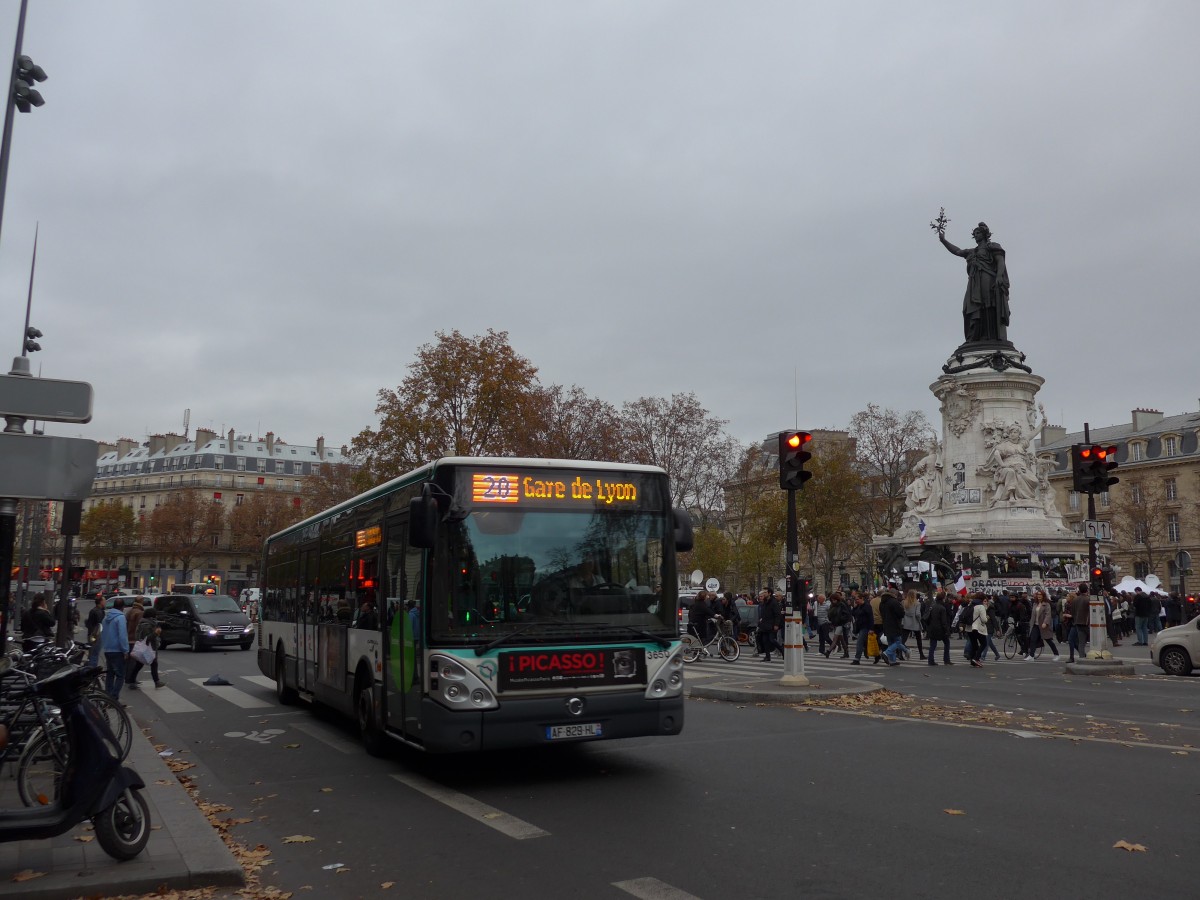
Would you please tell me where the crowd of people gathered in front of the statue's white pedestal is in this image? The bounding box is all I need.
[689,583,1200,668]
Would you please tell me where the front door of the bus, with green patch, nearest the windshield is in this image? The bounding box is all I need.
[384,515,425,739]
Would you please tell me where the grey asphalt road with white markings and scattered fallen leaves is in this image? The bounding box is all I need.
[126,648,1200,900]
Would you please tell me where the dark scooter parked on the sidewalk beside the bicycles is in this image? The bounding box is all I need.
[0,658,150,860]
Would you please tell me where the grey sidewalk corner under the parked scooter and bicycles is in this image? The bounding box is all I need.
[0,705,245,900]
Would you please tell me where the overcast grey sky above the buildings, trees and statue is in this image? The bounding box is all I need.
[0,0,1200,445]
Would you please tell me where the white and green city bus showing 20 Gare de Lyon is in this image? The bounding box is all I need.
[258,457,692,754]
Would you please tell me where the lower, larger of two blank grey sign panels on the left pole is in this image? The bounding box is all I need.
[0,432,96,500]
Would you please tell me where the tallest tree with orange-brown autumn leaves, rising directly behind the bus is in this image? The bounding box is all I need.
[352,329,538,484]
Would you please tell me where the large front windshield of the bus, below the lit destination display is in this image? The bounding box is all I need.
[428,509,677,642]
